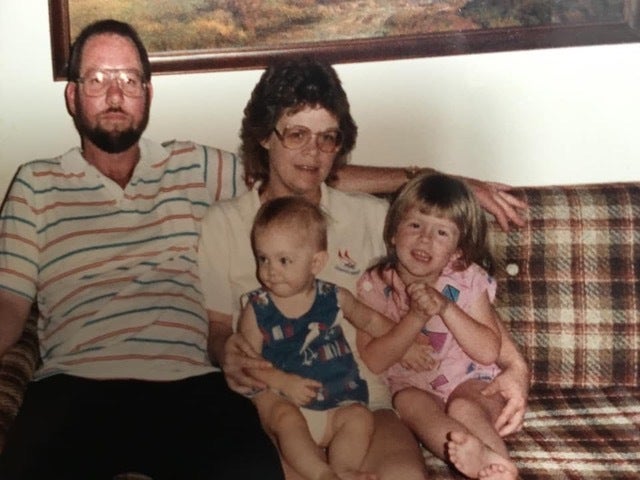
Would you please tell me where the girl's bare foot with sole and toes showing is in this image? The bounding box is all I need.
[447,432,518,480]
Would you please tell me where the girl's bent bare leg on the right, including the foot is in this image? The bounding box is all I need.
[447,380,518,480]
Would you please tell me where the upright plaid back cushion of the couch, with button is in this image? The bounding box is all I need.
[490,183,640,387]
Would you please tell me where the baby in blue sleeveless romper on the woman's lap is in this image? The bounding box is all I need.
[238,197,408,480]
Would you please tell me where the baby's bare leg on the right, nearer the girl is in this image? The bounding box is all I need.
[321,403,377,480]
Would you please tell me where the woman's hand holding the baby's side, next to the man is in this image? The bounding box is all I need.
[220,333,272,395]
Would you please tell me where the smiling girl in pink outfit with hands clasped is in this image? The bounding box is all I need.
[358,174,517,479]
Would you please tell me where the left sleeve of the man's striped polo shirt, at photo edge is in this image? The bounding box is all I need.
[0,166,39,301]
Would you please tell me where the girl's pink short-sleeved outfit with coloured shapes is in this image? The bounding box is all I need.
[358,264,500,402]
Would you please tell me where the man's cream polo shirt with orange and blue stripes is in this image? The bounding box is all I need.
[0,139,246,380]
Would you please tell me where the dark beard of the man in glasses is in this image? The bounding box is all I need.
[73,97,149,153]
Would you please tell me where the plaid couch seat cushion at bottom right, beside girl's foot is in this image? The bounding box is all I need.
[425,387,640,480]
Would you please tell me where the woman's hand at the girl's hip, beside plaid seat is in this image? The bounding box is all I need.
[482,362,530,437]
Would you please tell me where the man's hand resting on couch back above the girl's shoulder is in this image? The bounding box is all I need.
[460,177,527,232]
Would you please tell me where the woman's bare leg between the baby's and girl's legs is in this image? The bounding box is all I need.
[362,409,427,480]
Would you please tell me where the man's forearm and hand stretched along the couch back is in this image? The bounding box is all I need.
[332,165,527,231]
